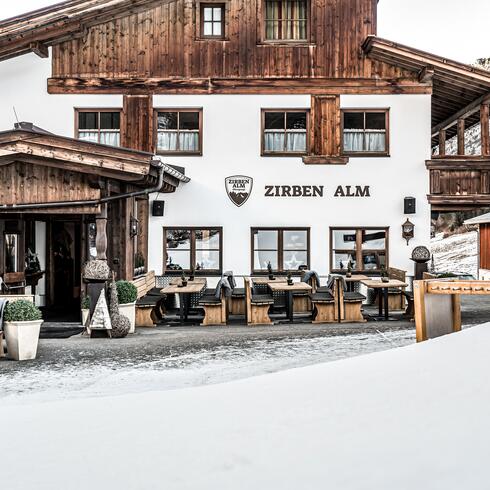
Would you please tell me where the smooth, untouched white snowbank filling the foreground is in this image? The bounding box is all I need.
[0,325,490,490]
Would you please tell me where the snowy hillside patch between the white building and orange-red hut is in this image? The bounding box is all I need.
[431,231,478,278]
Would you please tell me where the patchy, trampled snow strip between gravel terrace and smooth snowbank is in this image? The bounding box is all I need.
[0,326,415,405]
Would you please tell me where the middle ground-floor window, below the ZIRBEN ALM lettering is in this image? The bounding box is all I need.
[252,228,310,273]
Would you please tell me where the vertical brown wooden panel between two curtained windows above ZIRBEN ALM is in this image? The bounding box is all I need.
[303,95,348,164]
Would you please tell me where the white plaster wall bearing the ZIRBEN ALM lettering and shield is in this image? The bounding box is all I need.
[149,95,431,275]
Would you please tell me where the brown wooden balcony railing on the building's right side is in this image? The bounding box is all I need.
[426,155,490,210]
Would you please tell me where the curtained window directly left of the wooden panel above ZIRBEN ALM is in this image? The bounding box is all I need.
[262,109,308,155]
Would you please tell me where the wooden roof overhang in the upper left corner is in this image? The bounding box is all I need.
[0,0,175,61]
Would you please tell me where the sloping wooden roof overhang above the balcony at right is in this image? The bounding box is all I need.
[362,36,490,137]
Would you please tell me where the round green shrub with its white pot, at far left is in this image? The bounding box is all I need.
[4,299,43,361]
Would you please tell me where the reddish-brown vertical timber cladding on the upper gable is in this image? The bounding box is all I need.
[50,0,416,83]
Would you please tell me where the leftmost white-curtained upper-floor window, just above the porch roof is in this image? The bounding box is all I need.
[76,109,121,146]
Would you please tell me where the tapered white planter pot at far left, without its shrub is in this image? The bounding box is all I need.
[4,320,43,361]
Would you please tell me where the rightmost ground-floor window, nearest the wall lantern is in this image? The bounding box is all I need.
[330,228,389,272]
